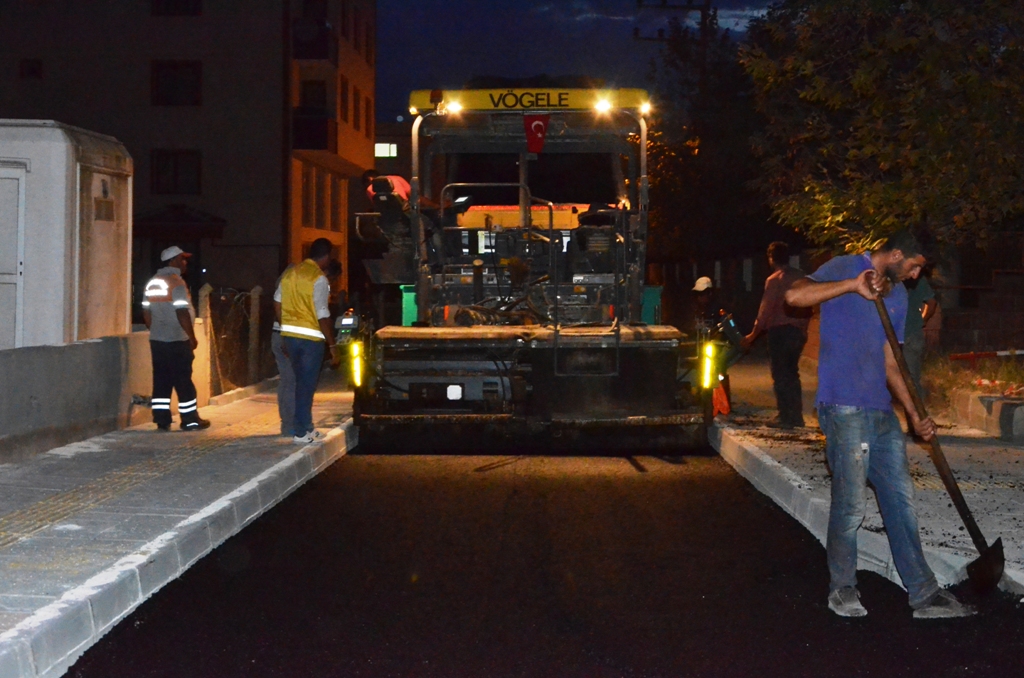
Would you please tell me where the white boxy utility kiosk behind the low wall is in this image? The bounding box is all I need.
[0,119,132,350]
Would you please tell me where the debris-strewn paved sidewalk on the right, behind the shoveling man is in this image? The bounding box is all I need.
[713,359,1024,593]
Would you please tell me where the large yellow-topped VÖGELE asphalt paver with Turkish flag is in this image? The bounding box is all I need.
[349,89,717,454]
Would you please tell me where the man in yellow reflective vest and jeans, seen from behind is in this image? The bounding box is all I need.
[273,238,341,444]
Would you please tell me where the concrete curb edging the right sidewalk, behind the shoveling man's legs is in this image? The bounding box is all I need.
[708,424,1024,594]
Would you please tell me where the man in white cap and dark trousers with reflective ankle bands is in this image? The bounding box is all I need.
[142,245,210,431]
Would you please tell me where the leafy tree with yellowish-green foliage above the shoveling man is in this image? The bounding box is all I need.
[740,0,1024,249]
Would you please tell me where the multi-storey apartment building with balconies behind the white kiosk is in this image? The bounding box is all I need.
[0,0,377,307]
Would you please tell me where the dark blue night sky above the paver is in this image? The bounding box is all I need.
[377,0,769,121]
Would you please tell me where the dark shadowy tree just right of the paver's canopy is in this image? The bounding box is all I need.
[648,10,782,259]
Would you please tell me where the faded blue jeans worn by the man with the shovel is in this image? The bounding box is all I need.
[818,404,939,607]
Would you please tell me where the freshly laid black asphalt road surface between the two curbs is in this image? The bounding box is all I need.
[69,454,1024,678]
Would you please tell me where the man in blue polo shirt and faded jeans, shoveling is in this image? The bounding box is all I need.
[785,230,975,619]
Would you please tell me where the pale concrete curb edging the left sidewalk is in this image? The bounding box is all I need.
[0,419,358,678]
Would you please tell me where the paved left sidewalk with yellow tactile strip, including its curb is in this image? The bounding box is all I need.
[0,378,356,678]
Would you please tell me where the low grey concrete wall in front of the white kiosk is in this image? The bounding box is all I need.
[0,319,210,463]
